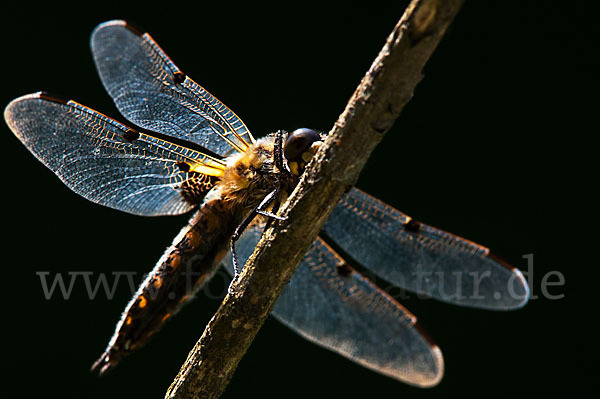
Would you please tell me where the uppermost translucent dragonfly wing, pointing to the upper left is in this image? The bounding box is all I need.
[91,21,254,156]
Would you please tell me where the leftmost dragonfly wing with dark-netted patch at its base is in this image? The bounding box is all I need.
[4,93,223,216]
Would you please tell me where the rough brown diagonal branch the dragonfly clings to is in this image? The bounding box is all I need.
[166,0,463,399]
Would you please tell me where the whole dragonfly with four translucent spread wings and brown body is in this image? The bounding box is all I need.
[4,20,529,387]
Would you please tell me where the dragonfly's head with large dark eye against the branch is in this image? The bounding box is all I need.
[283,128,322,176]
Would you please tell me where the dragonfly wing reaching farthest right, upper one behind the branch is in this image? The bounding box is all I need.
[323,188,529,310]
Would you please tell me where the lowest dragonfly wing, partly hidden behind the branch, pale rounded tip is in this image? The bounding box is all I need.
[223,226,443,387]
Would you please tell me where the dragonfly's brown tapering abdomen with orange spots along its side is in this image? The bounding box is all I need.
[92,199,244,374]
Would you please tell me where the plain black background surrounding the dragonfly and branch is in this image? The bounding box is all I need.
[0,1,597,398]
